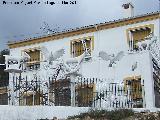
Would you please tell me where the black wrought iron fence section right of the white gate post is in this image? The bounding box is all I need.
[76,78,144,108]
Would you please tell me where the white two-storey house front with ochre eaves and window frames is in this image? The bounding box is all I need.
[6,6,160,108]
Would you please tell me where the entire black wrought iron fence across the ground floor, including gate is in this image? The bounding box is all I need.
[9,77,145,108]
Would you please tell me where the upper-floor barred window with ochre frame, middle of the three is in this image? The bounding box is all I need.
[71,36,94,57]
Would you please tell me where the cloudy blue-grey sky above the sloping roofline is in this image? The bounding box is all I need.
[0,0,160,50]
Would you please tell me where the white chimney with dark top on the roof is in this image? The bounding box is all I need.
[122,0,134,18]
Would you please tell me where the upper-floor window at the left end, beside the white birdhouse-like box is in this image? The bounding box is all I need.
[25,48,40,70]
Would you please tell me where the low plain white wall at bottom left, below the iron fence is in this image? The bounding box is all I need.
[0,105,89,120]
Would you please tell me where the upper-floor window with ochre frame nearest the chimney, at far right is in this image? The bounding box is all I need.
[127,24,154,51]
